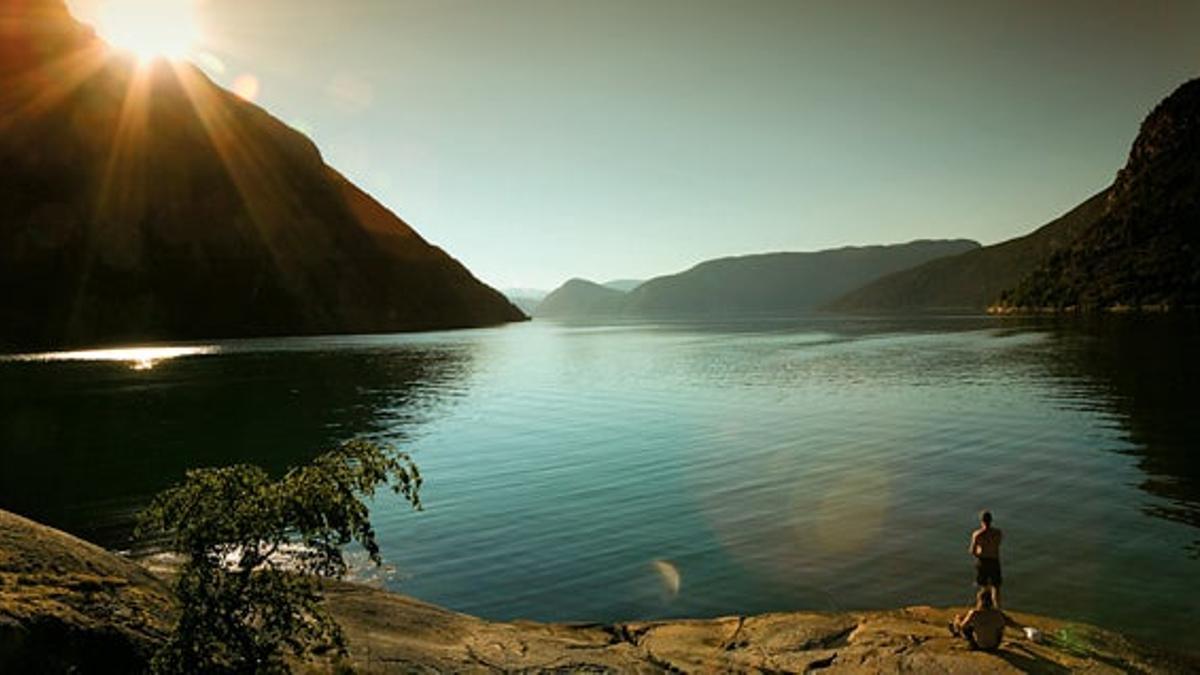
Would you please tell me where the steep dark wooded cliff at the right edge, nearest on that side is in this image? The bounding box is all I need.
[1000,79,1200,310]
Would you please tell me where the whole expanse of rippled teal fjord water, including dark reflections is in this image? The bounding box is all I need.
[0,316,1200,645]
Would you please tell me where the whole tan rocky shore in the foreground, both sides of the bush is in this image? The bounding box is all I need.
[0,512,1200,673]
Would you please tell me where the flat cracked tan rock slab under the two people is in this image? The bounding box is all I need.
[311,584,1200,673]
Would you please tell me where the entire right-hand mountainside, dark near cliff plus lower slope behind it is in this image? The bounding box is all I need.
[826,78,1200,313]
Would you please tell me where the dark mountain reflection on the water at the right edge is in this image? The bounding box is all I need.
[1044,315,1200,556]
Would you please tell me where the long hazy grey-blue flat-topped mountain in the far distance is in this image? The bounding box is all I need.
[624,239,979,316]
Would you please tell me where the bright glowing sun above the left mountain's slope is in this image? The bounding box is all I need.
[96,0,200,61]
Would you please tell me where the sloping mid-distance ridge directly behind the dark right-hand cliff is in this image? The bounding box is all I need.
[826,190,1108,311]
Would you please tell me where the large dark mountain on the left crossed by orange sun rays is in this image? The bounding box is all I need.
[0,0,523,348]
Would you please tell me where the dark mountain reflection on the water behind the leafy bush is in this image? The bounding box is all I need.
[0,345,472,545]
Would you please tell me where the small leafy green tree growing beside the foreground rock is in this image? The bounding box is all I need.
[139,441,421,673]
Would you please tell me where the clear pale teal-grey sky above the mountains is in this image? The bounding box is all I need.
[70,0,1200,288]
